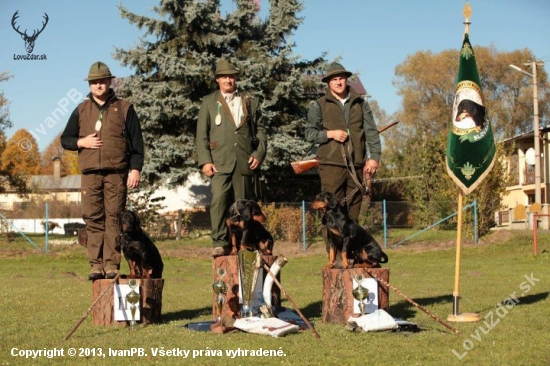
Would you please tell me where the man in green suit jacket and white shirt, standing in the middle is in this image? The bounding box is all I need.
[196,59,267,257]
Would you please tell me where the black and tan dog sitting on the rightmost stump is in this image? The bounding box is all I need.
[311,192,388,268]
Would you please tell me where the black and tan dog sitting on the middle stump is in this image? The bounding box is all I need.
[226,199,273,255]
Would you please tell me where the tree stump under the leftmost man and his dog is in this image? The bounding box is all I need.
[92,278,164,325]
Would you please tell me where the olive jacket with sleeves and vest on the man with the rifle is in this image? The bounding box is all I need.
[305,86,382,166]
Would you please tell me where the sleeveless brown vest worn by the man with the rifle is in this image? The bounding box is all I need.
[317,88,366,166]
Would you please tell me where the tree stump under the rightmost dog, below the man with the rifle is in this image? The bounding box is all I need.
[322,268,390,323]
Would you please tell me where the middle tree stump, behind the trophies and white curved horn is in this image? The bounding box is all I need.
[212,255,281,320]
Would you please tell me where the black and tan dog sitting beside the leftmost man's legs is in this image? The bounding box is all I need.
[117,210,164,279]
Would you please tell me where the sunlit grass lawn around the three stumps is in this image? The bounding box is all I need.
[0,231,550,365]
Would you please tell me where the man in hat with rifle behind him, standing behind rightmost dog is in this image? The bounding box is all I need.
[305,63,381,222]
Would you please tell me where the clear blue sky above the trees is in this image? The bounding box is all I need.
[0,0,550,150]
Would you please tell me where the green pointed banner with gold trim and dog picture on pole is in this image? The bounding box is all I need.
[447,33,496,195]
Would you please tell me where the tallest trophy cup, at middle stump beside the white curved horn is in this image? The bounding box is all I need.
[239,250,262,318]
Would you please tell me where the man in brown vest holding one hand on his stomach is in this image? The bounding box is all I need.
[61,61,144,281]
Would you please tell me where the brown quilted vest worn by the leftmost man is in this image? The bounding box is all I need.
[78,97,130,173]
